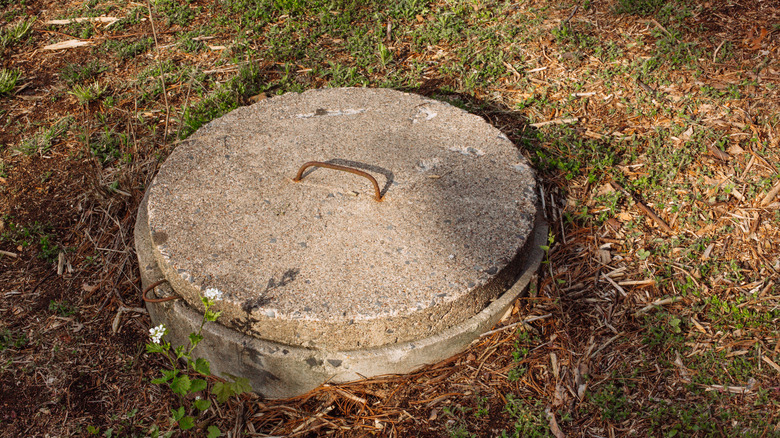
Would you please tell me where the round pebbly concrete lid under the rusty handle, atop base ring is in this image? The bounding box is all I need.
[148,88,536,350]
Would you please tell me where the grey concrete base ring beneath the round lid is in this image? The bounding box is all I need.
[135,190,548,399]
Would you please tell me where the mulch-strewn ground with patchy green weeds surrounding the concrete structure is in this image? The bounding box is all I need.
[0,0,780,437]
